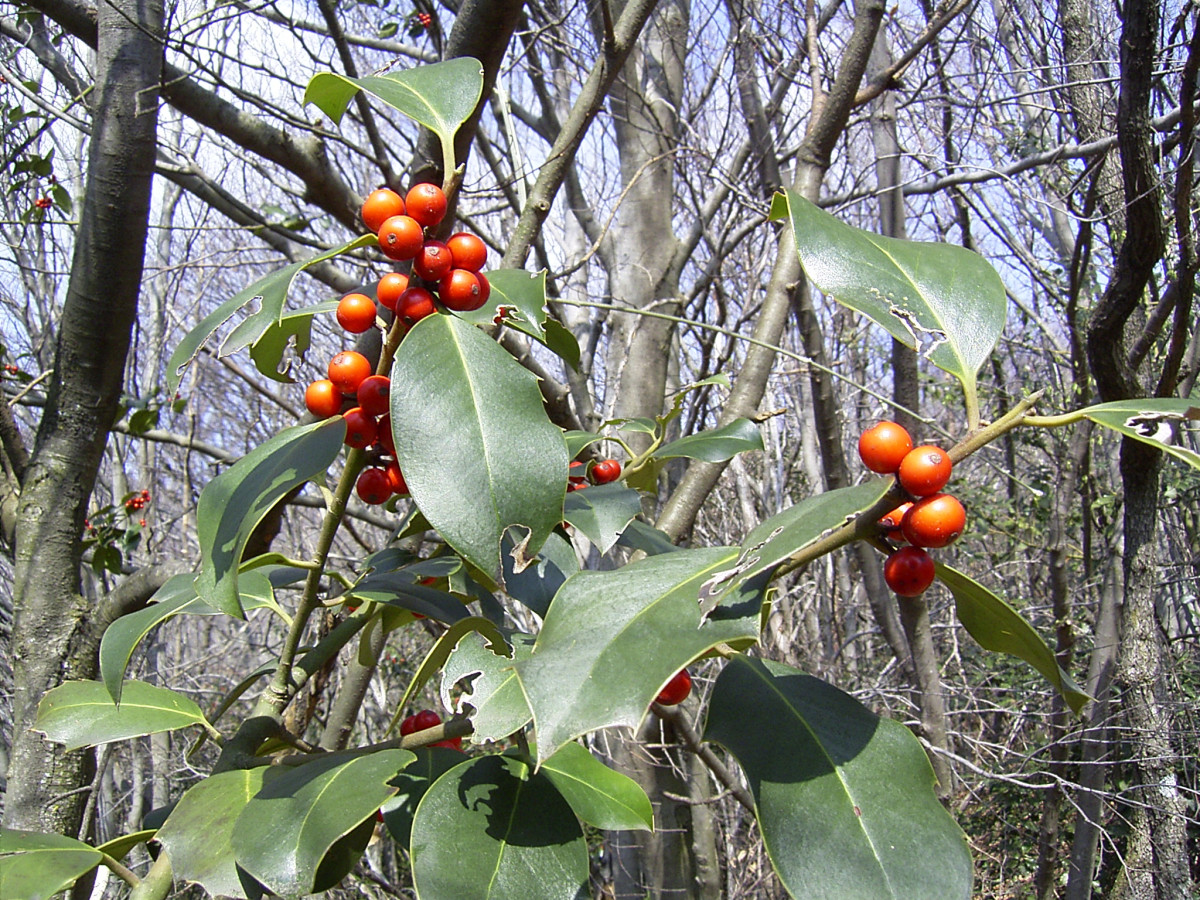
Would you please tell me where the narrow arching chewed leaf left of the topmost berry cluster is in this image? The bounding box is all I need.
[167,234,379,395]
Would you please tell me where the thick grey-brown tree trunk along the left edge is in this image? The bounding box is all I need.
[4,0,163,835]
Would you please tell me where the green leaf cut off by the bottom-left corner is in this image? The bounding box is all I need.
[0,828,103,900]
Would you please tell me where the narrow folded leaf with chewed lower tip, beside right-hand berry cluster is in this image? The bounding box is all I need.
[700,478,892,613]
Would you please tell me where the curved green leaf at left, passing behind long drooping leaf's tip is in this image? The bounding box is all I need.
[100,572,274,703]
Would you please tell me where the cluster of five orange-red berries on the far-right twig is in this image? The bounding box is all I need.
[858,421,967,596]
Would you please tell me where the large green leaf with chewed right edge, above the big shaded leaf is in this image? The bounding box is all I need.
[516,547,761,761]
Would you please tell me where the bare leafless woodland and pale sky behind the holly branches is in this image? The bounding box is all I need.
[0,0,1200,898]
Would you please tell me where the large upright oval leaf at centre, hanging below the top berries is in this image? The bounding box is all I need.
[391,316,568,581]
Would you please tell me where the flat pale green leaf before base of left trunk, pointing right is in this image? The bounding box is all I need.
[34,682,212,751]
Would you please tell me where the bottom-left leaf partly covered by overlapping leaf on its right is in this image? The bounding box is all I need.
[157,766,268,896]
